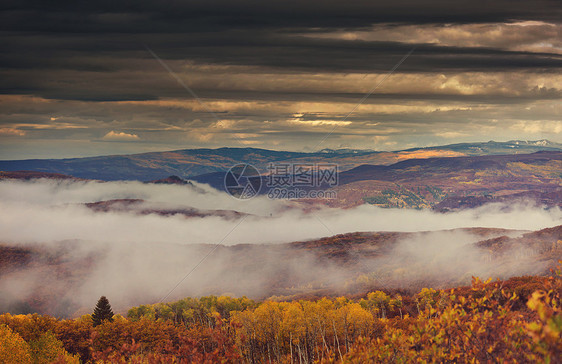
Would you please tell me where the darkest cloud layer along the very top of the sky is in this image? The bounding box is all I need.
[0,0,561,33]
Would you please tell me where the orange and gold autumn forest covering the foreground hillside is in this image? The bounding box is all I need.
[0,270,562,363]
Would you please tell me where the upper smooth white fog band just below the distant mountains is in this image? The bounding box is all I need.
[0,180,562,245]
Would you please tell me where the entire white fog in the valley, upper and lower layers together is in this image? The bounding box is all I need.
[0,180,562,316]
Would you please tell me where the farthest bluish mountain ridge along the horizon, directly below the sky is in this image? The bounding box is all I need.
[0,139,562,181]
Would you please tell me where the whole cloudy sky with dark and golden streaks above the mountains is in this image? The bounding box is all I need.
[0,0,562,159]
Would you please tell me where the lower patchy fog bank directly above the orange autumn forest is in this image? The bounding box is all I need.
[0,230,547,317]
